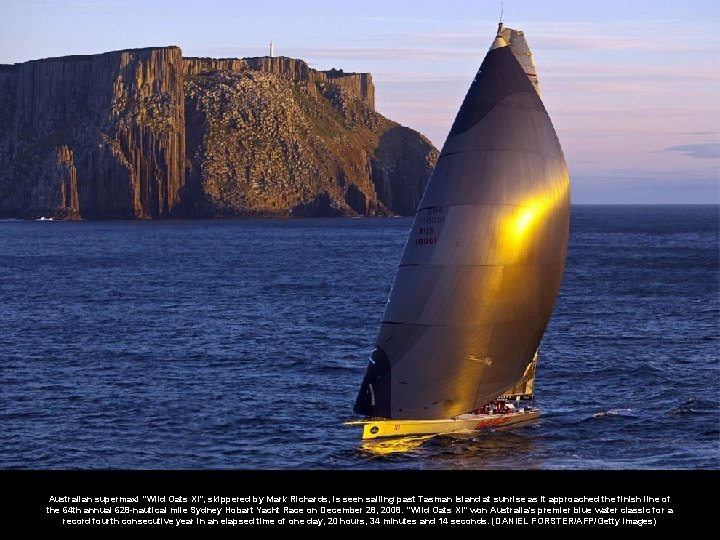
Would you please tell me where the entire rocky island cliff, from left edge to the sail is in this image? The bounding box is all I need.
[0,47,437,219]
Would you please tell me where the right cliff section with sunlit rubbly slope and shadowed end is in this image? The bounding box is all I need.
[185,54,437,216]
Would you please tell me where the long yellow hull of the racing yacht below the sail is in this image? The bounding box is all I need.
[345,410,540,439]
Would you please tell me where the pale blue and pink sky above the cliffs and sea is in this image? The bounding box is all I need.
[0,0,720,204]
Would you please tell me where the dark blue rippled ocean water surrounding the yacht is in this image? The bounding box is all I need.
[0,206,720,469]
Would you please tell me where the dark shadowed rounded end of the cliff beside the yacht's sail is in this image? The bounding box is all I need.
[371,126,439,216]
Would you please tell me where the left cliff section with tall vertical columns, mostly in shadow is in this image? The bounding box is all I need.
[0,47,185,218]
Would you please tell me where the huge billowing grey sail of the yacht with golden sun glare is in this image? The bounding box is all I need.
[354,24,570,420]
